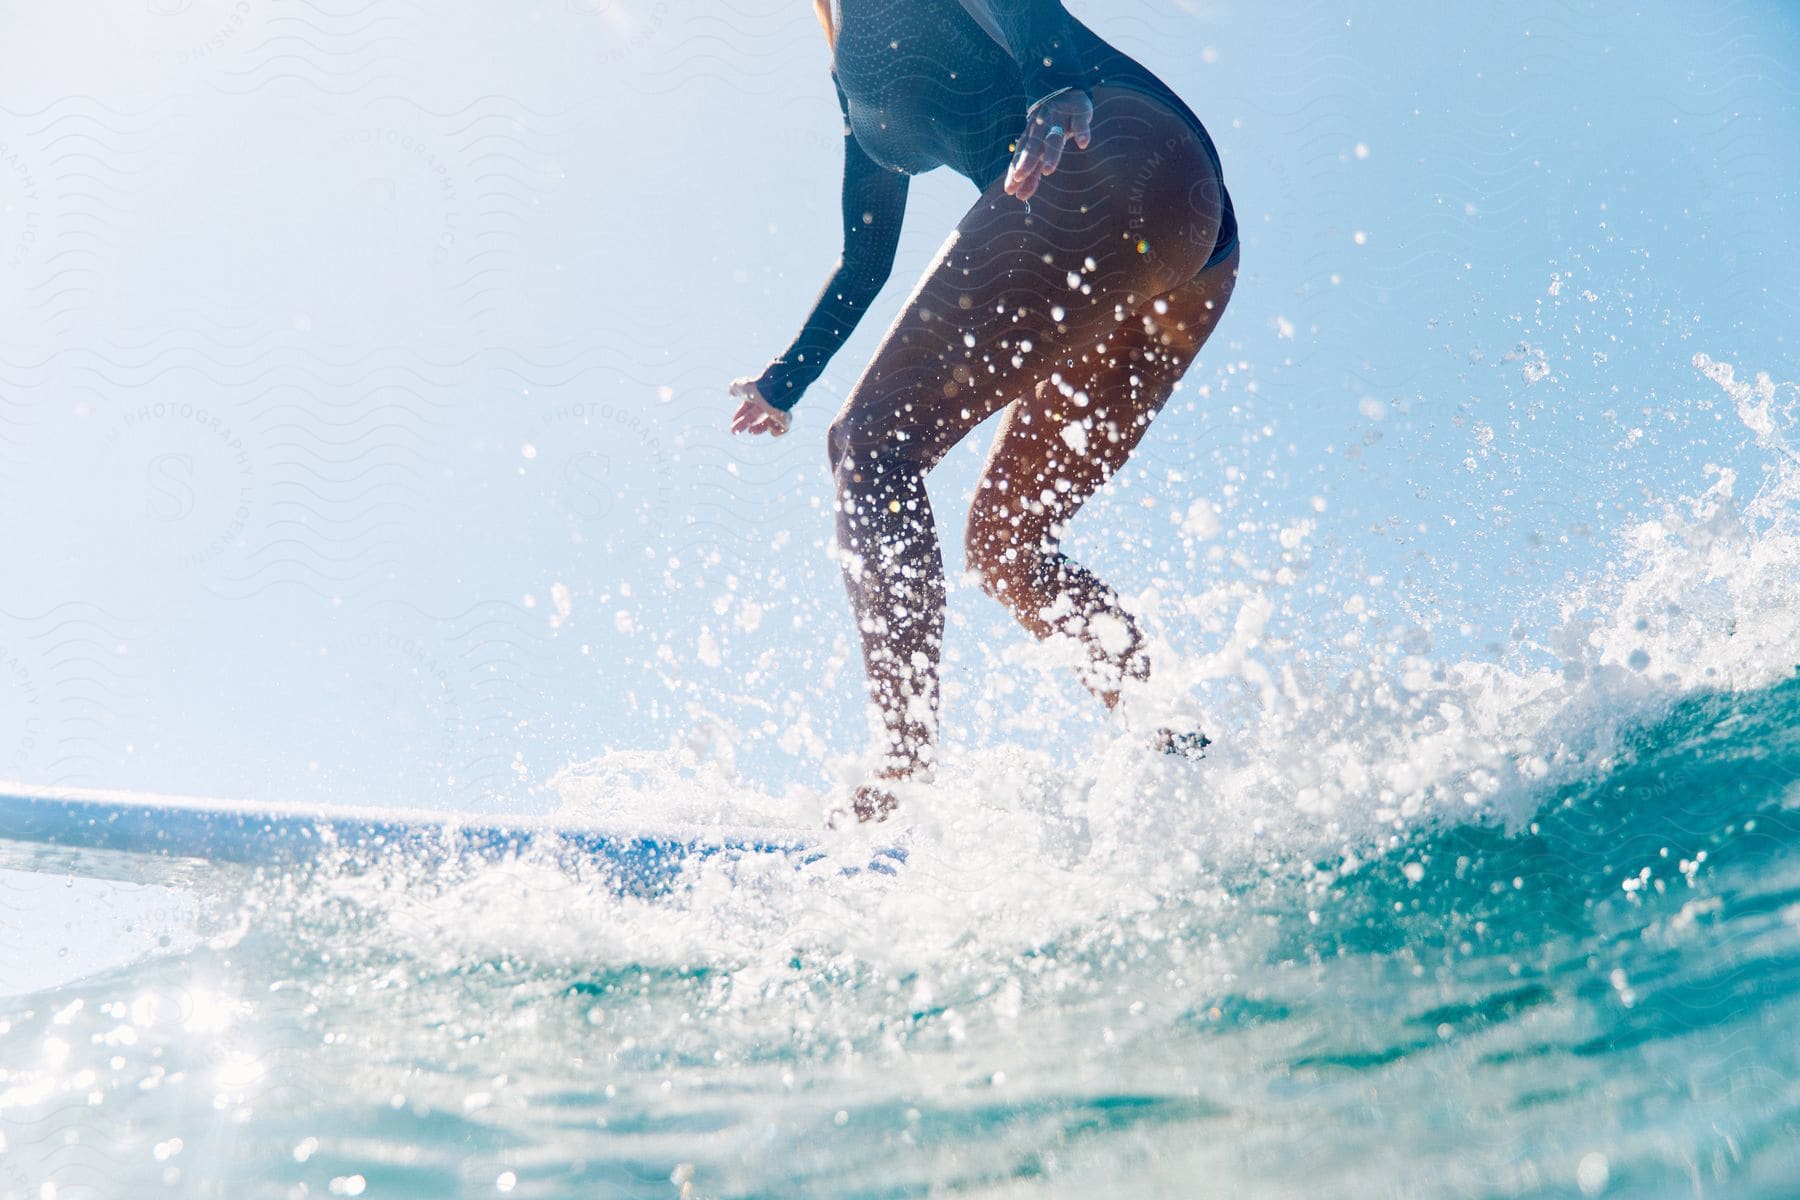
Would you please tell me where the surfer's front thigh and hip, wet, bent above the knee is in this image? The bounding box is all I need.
[830,88,1222,470]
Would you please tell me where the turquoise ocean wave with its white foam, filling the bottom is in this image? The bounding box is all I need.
[0,372,1800,1200]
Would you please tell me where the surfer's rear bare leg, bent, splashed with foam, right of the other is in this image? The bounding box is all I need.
[965,250,1238,707]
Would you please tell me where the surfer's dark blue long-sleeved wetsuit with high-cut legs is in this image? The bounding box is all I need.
[758,0,1237,410]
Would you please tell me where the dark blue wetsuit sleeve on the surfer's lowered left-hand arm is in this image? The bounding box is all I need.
[756,76,909,410]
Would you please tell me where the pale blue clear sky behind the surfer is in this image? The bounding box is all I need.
[0,0,1800,808]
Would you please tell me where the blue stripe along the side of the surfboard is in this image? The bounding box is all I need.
[0,790,905,894]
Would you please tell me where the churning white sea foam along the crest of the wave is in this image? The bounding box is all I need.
[288,358,1800,1006]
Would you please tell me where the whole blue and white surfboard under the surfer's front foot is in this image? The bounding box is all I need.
[0,784,905,896]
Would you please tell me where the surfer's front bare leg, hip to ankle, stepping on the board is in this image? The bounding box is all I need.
[828,88,1222,817]
